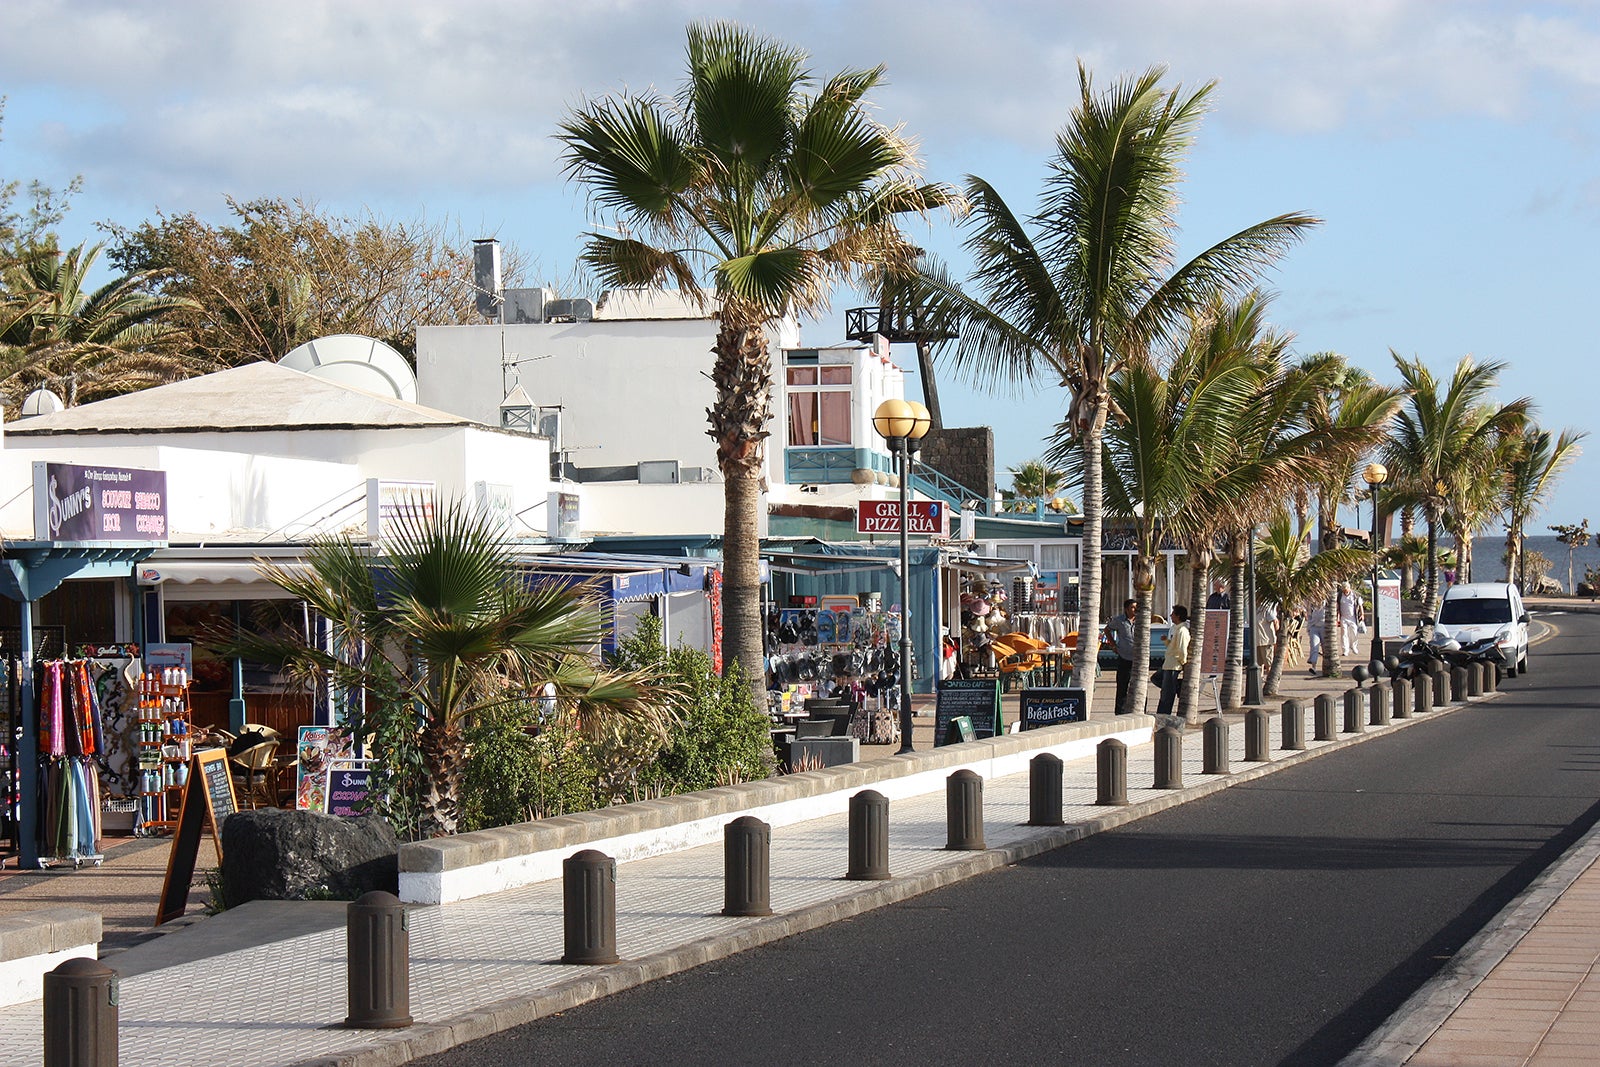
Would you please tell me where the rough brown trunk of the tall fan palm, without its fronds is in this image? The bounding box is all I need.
[707,323,773,707]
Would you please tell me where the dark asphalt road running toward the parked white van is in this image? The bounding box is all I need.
[419,616,1600,1067]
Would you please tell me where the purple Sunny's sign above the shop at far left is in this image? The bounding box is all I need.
[34,462,166,544]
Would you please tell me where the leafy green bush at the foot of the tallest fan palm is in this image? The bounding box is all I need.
[611,617,773,795]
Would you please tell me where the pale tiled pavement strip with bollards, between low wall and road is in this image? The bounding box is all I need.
[0,684,1493,1067]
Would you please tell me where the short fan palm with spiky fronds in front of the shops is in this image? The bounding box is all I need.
[226,501,675,835]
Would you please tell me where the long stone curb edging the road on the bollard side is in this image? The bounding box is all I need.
[293,691,1497,1067]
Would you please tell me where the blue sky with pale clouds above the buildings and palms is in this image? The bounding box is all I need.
[0,0,1600,534]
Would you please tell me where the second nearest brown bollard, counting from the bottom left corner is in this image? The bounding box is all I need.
[344,889,411,1030]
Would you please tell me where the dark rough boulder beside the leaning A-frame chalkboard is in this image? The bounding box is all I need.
[222,808,400,907]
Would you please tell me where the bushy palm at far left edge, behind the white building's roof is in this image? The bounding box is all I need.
[0,243,194,405]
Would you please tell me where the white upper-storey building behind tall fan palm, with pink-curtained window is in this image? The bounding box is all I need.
[418,290,960,534]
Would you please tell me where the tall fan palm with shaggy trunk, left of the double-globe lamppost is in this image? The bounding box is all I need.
[558,22,954,699]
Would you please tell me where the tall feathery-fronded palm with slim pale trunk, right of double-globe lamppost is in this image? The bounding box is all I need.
[908,64,1317,716]
